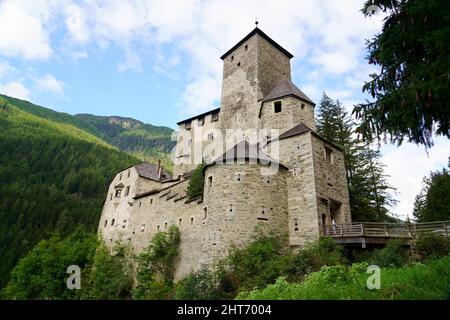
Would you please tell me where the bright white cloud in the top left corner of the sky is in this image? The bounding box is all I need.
[0,1,52,59]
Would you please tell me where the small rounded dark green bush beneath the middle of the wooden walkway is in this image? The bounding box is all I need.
[369,240,410,267]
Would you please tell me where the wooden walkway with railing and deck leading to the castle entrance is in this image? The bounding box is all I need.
[323,221,450,248]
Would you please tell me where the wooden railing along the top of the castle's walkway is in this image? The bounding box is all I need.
[323,221,450,238]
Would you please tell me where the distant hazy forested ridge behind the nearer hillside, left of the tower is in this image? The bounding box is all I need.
[0,95,175,170]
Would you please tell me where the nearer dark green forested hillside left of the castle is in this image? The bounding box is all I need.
[0,97,140,286]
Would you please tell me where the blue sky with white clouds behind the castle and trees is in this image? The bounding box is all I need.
[0,0,450,218]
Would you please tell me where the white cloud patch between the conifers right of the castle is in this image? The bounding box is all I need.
[381,137,450,218]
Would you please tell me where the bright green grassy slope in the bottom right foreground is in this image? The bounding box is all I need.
[237,256,450,300]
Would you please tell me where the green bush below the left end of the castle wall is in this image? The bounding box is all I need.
[82,243,133,300]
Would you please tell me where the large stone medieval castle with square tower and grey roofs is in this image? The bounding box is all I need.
[99,27,351,279]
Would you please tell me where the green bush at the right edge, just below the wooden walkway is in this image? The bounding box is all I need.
[415,233,450,260]
